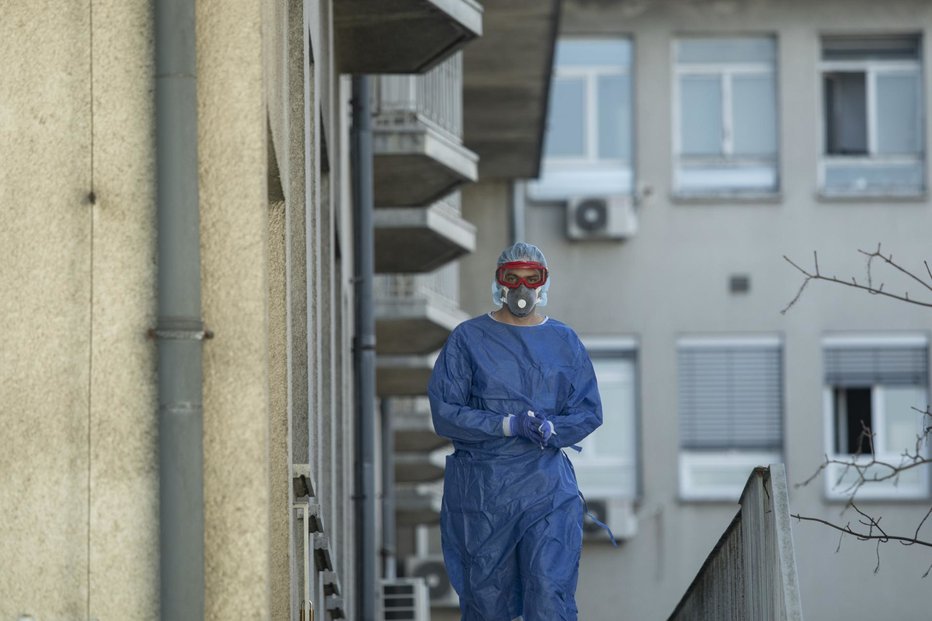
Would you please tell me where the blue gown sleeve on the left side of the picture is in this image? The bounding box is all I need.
[427,331,505,442]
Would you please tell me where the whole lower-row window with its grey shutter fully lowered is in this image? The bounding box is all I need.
[677,337,783,501]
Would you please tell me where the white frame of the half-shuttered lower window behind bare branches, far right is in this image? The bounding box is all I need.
[822,334,930,501]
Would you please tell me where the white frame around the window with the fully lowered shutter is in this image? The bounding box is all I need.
[676,335,786,502]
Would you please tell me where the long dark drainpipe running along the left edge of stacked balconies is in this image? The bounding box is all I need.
[352,75,378,621]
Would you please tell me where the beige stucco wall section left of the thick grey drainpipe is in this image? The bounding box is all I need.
[0,0,158,619]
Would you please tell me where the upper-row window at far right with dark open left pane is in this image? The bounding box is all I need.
[820,36,925,196]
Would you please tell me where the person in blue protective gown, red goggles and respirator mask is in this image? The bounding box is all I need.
[428,243,602,621]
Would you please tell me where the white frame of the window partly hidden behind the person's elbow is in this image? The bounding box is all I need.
[566,337,640,501]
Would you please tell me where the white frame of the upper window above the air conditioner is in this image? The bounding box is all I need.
[527,35,635,200]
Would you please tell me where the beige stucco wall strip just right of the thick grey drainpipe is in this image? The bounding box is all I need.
[197,0,270,619]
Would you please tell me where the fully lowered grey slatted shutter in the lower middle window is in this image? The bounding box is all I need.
[678,344,783,450]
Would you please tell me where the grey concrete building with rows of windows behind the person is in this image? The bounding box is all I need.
[454,0,932,621]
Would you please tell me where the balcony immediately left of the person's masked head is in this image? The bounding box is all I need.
[373,263,469,356]
